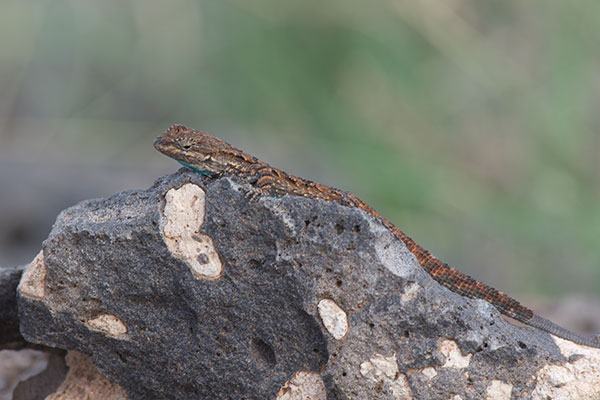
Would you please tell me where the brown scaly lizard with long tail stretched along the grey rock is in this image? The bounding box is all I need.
[154,124,600,348]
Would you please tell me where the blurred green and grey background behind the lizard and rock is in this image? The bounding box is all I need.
[0,0,600,296]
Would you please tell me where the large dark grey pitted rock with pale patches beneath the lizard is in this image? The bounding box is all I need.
[19,170,600,400]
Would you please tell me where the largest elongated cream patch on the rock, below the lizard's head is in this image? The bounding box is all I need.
[161,183,223,279]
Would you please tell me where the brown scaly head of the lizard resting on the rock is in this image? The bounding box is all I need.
[154,124,254,175]
